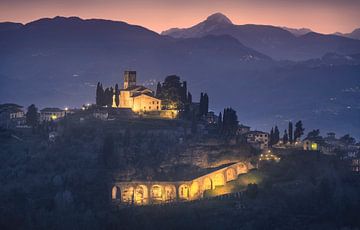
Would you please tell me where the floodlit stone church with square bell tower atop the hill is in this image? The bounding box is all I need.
[112,71,161,113]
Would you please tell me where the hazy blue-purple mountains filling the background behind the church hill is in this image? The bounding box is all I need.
[0,14,360,137]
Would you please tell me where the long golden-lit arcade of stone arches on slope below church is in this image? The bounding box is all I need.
[110,162,253,205]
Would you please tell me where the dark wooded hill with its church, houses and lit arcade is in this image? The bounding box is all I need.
[0,71,360,227]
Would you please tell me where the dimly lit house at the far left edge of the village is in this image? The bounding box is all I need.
[0,103,26,128]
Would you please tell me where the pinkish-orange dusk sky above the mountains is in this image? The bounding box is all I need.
[0,0,360,33]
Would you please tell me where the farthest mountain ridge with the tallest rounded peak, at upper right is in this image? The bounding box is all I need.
[161,13,360,60]
